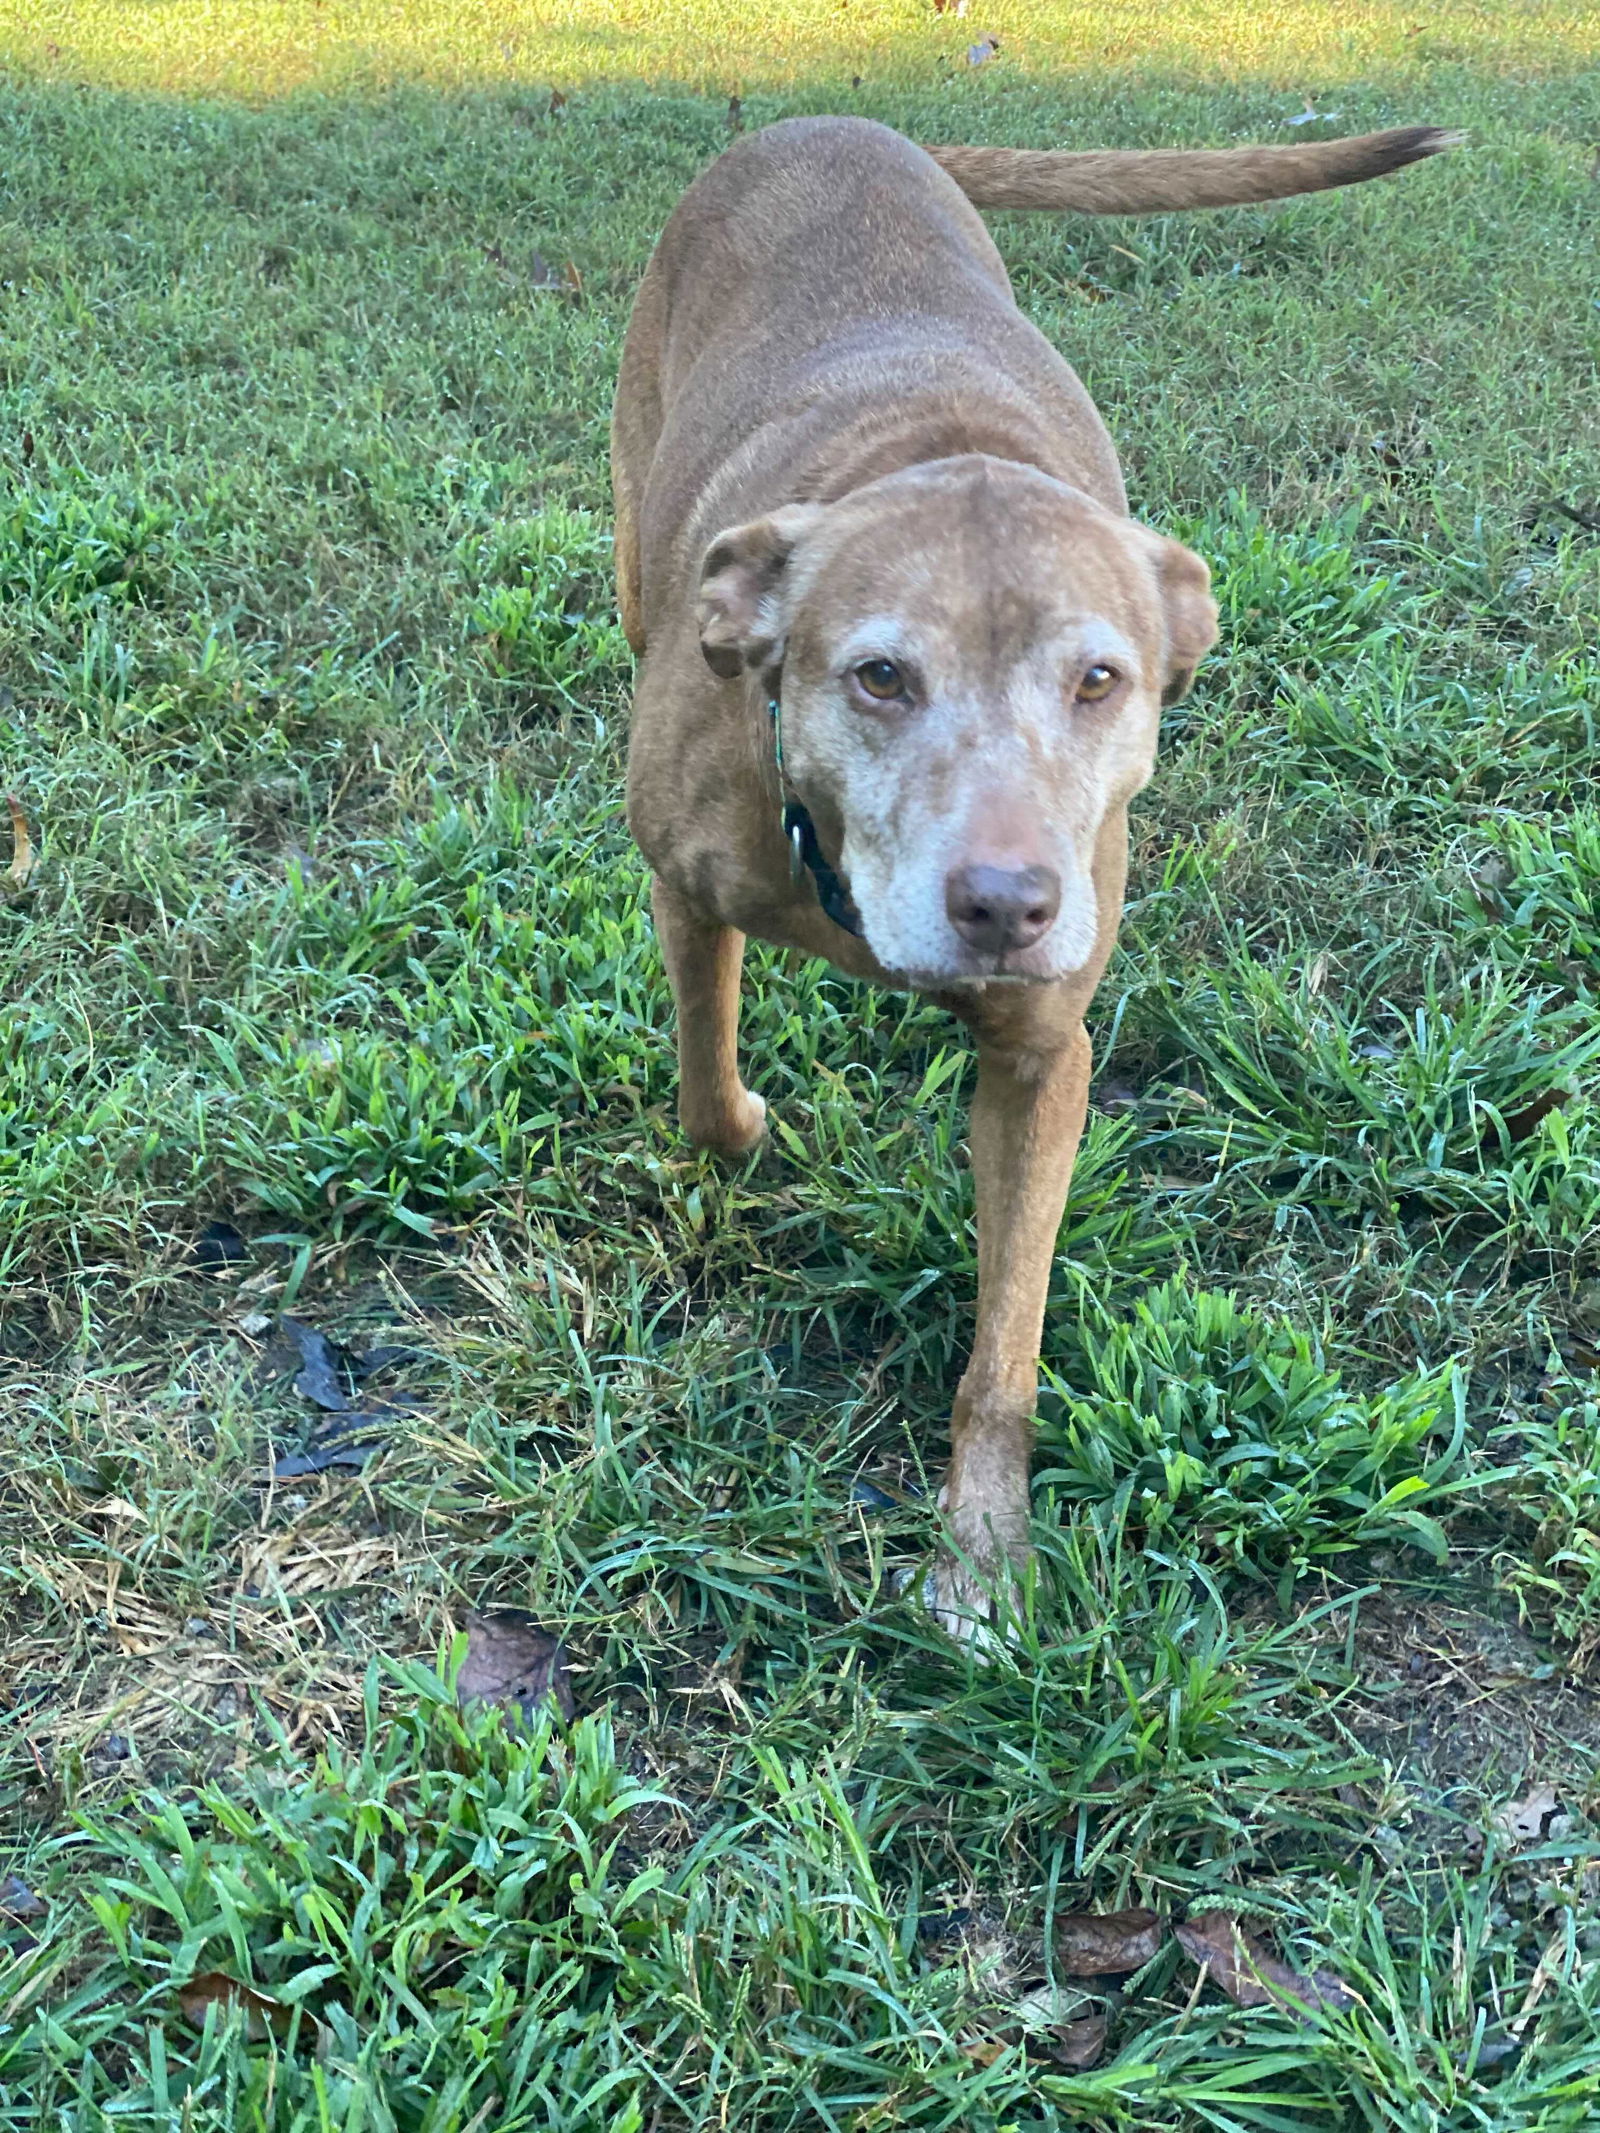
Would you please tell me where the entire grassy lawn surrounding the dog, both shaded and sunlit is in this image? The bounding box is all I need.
[0,0,1600,2133]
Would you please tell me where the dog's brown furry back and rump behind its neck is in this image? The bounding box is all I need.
[612,117,1122,646]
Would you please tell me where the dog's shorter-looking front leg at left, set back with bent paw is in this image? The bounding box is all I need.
[651,875,766,1156]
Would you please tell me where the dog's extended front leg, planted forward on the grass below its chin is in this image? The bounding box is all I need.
[932,1024,1090,1636]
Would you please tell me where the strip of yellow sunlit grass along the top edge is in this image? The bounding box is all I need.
[0,0,1600,98]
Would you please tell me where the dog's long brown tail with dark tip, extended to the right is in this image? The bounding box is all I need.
[928,126,1463,215]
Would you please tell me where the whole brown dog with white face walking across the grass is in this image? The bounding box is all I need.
[612,119,1455,1627]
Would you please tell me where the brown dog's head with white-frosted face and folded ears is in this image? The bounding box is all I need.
[698,456,1216,988]
